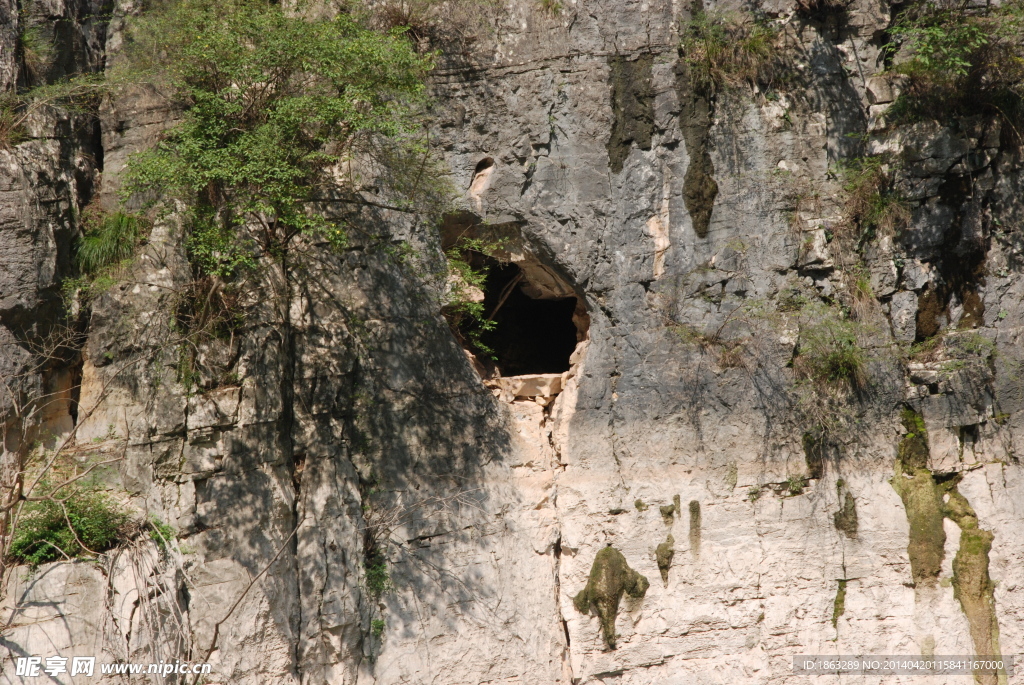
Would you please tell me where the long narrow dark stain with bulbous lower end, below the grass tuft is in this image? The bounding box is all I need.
[676,50,718,238]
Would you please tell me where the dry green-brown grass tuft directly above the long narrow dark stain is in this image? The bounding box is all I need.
[680,12,778,95]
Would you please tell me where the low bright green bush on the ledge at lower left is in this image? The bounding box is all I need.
[9,490,132,566]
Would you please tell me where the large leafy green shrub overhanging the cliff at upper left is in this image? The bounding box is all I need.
[123,0,432,277]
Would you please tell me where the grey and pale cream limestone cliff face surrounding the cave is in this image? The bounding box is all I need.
[0,0,1024,685]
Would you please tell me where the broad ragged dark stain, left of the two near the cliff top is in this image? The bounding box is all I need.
[608,54,654,174]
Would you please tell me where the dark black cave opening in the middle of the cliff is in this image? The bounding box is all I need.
[475,262,583,376]
